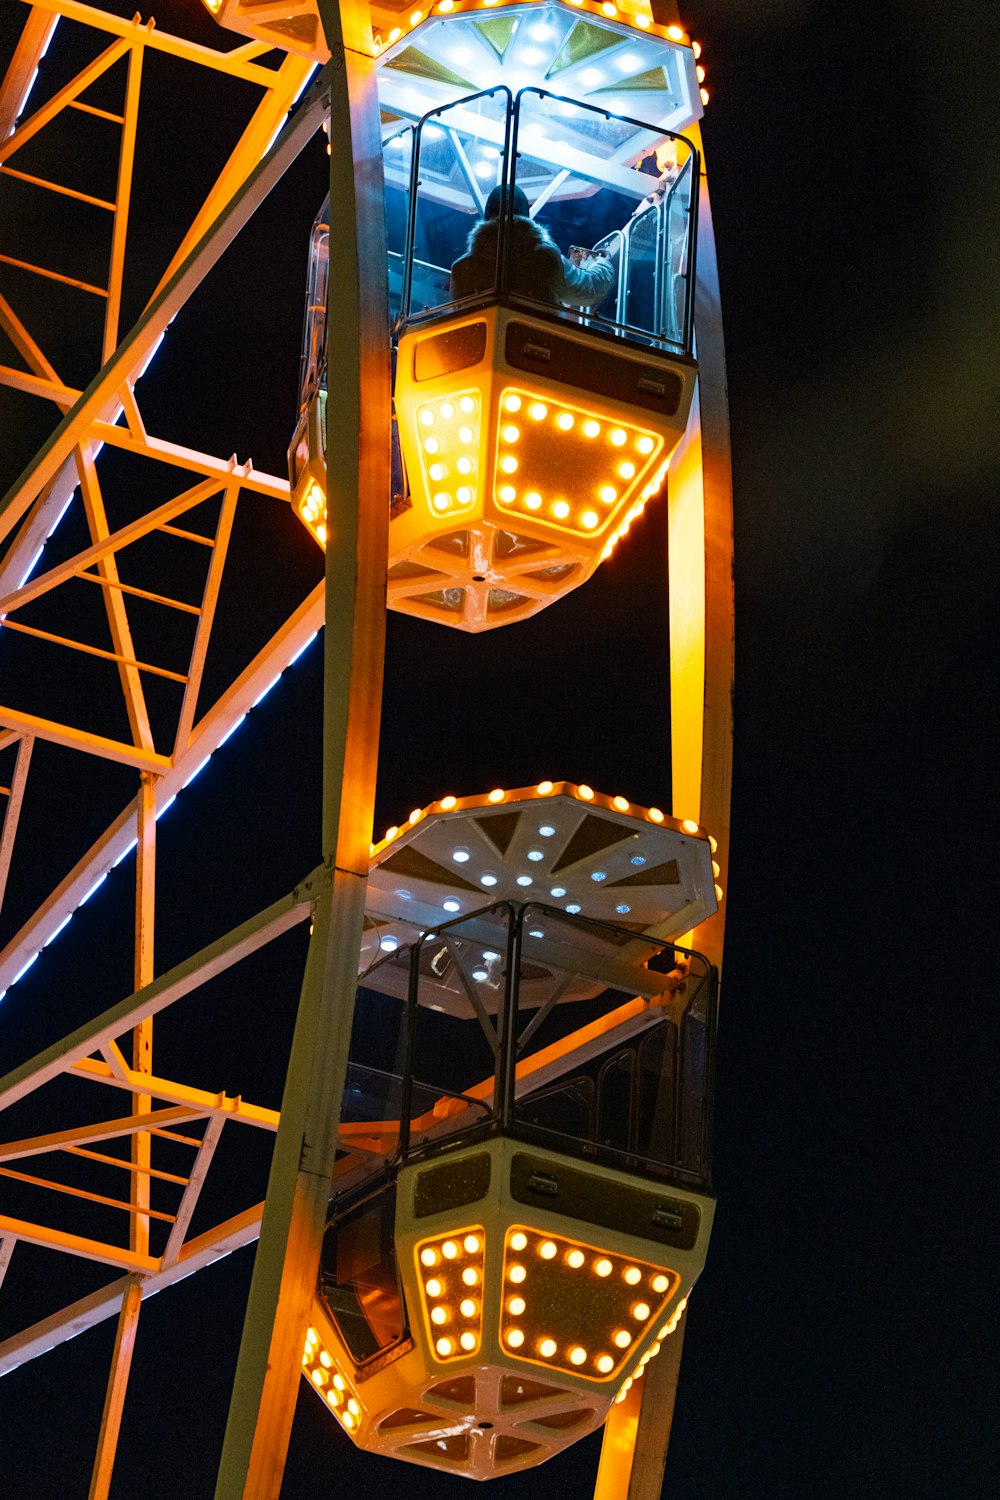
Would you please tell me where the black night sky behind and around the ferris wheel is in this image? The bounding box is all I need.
[0,0,1000,1500]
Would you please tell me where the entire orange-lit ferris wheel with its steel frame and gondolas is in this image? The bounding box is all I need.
[0,0,733,1500]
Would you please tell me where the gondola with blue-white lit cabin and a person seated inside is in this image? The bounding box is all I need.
[277,3,700,632]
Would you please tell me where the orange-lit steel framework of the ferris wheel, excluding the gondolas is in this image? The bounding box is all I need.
[0,0,732,1500]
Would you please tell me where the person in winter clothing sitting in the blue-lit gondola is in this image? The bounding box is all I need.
[451,188,615,308]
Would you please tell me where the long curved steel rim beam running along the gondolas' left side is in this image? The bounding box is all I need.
[216,0,390,1500]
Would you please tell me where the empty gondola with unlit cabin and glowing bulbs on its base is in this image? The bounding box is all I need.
[303,783,717,1479]
